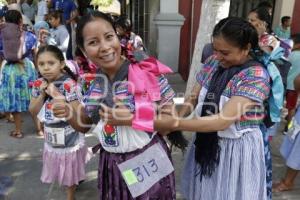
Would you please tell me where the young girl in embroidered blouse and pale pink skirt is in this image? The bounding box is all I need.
[29,45,87,200]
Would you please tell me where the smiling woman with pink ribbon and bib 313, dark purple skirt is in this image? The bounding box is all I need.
[54,11,186,200]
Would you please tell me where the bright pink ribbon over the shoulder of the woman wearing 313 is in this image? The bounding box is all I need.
[128,57,172,132]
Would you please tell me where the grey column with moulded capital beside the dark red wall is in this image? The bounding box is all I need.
[154,0,184,72]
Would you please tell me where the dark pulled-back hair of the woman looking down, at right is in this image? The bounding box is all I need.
[212,17,258,49]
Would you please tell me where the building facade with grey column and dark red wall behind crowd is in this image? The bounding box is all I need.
[120,0,300,80]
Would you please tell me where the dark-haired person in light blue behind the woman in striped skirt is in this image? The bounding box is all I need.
[248,7,290,200]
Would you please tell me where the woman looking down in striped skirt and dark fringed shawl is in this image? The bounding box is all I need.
[168,17,270,200]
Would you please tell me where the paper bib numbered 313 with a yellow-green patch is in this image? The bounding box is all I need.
[118,143,174,198]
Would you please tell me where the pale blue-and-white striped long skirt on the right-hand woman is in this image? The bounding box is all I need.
[181,131,267,200]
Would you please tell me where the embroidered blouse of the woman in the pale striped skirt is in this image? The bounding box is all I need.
[196,56,270,138]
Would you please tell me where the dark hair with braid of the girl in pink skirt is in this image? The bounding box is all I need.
[36,45,77,81]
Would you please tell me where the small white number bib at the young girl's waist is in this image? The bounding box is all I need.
[45,126,72,147]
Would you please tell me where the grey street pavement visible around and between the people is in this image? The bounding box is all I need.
[0,74,300,200]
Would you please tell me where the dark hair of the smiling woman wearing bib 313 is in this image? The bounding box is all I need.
[76,10,116,48]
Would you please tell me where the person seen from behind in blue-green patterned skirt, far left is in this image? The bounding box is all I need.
[0,10,37,138]
